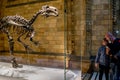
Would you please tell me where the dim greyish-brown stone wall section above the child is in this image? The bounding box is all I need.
[92,0,112,55]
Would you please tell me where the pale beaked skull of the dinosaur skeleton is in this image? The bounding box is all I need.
[42,5,58,17]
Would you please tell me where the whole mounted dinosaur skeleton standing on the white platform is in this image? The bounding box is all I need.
[0,5,58,68]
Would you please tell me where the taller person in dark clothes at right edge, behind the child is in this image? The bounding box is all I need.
[105,32,120,80]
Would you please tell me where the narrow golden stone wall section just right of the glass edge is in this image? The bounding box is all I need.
[67,0,85,69]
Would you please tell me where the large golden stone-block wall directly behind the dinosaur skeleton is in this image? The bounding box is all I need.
[0,0,64,67]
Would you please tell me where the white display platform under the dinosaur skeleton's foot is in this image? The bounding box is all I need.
[0,62,81,80]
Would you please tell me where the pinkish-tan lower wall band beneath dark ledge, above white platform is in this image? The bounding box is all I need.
[0,52,69,68]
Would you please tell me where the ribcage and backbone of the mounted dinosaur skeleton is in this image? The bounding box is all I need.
[0,16,31,36]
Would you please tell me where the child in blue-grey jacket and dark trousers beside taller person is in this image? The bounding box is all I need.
[95,38,110,80]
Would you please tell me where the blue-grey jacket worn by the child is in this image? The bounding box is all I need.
[95,46,110,66]
